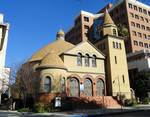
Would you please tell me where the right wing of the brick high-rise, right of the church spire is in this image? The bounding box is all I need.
[109,0,150,53]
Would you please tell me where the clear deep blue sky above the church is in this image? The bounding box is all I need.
[0,0,149,67]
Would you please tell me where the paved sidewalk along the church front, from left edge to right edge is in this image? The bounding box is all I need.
[0,105,150,117]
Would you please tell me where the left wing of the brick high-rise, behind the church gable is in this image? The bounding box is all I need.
[65,11,101,44]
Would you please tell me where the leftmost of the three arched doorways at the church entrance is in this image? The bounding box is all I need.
[69,78,80,97]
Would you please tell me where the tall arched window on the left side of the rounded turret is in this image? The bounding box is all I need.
[44,76,51,93]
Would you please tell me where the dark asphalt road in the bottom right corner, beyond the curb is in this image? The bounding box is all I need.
[100,110,150,117]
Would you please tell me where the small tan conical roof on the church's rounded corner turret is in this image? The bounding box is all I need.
[38,51,66,69]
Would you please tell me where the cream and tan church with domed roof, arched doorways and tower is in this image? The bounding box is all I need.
[20,11,131,106]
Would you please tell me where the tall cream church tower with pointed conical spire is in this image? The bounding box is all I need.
[95,10,131,98]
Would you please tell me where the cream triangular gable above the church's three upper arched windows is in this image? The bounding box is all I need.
[64,41,105,59]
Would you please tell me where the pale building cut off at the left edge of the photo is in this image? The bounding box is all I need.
[0,14,10,103]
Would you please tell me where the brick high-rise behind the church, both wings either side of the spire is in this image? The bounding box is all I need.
[66,0,150,53]
